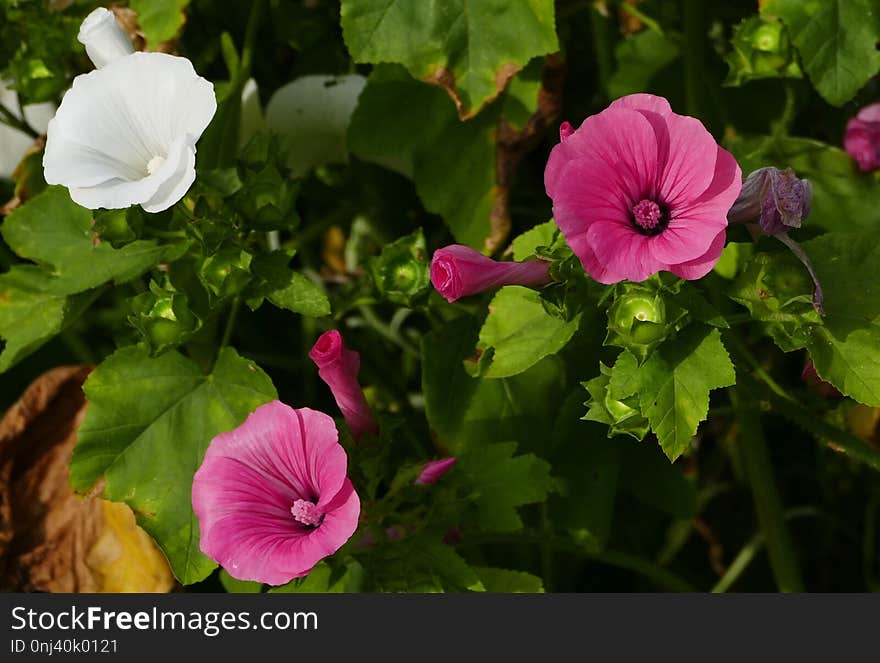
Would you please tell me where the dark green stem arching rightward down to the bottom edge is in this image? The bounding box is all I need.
[462,532,697,592]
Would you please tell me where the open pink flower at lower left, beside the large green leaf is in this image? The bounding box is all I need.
[192,401,361,585]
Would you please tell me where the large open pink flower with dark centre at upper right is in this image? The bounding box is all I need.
[544,94,742,283]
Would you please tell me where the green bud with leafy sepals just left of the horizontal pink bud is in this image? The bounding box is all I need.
[369,228,431,306]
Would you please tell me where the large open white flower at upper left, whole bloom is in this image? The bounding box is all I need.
[43,53,217,212]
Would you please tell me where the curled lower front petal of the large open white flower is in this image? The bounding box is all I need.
[70,136,195,212]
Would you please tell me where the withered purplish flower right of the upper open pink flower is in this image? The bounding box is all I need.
[727,167,813,235]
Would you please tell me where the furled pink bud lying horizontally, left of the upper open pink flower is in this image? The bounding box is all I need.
[431,244,552,303]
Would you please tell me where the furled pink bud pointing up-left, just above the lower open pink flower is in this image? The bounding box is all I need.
[309,329,379,440]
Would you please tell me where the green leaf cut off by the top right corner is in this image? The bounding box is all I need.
[761,0,880,106]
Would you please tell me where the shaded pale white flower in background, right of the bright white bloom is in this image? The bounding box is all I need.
[266,74,366,175]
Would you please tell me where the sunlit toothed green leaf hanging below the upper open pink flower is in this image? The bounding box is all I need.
[639,325,736,460]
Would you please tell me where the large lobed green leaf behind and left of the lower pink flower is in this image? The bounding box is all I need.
[70,347,276,584]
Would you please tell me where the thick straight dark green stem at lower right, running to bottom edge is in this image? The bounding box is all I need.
[729,387,804,592]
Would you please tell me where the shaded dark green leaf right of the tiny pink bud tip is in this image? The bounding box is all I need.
[450,442,551,532]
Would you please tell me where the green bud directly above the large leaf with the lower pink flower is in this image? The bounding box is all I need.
[128,277,202,356]
